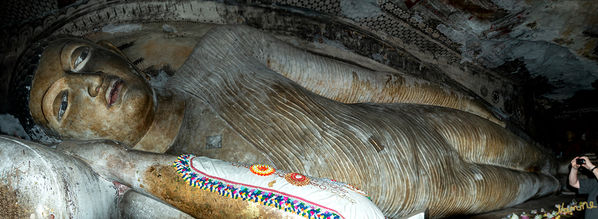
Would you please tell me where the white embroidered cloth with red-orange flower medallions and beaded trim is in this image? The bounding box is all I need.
[173,154,384,219]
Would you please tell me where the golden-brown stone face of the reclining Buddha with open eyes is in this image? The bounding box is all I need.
[29,39,155,145]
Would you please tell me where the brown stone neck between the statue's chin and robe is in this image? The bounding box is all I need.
[133,95,185,153]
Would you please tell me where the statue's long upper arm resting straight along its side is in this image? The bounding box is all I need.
[212,26,504,126]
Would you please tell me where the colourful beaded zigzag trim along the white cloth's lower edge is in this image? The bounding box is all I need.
[173,154,344,219]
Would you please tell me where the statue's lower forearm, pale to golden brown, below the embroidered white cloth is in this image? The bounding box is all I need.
[57,142,296,218]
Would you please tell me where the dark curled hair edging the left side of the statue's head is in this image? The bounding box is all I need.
[8,38,60,144]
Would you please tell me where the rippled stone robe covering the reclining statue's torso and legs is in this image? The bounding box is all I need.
[169,26,558,217]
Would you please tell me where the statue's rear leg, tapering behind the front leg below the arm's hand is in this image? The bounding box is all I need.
[419,107,555,173]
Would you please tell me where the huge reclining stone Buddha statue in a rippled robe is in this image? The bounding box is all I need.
[11,25,558,218]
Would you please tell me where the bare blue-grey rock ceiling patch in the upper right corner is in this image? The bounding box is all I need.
[418,0,598,99]
